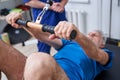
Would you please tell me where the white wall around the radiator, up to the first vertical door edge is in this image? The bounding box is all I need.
[66,0,102,33]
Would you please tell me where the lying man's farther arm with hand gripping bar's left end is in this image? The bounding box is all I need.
[6,12,62,49]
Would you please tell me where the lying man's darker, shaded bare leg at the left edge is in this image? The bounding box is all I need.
[0,40,26,80]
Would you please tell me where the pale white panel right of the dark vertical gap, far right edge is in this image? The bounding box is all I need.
[111,0,120,40]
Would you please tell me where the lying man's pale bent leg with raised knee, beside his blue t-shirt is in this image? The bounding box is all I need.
[24,53,68,80]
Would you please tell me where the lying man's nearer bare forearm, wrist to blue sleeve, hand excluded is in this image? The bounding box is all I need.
[75,33,109,65]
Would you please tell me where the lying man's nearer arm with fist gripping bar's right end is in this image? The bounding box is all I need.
[54,21,109,65]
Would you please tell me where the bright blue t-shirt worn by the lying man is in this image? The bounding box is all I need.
[54,40,113,80]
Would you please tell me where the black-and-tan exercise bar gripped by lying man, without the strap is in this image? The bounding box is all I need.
[16,19,77,39]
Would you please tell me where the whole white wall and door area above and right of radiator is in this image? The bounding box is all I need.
[66,0,120,40]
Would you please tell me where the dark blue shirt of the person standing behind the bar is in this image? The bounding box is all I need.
[32,0,67,26]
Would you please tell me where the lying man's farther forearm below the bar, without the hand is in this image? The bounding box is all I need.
[26,27,62,49]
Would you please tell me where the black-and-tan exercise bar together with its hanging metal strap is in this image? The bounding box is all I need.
[16,0,76,39]
